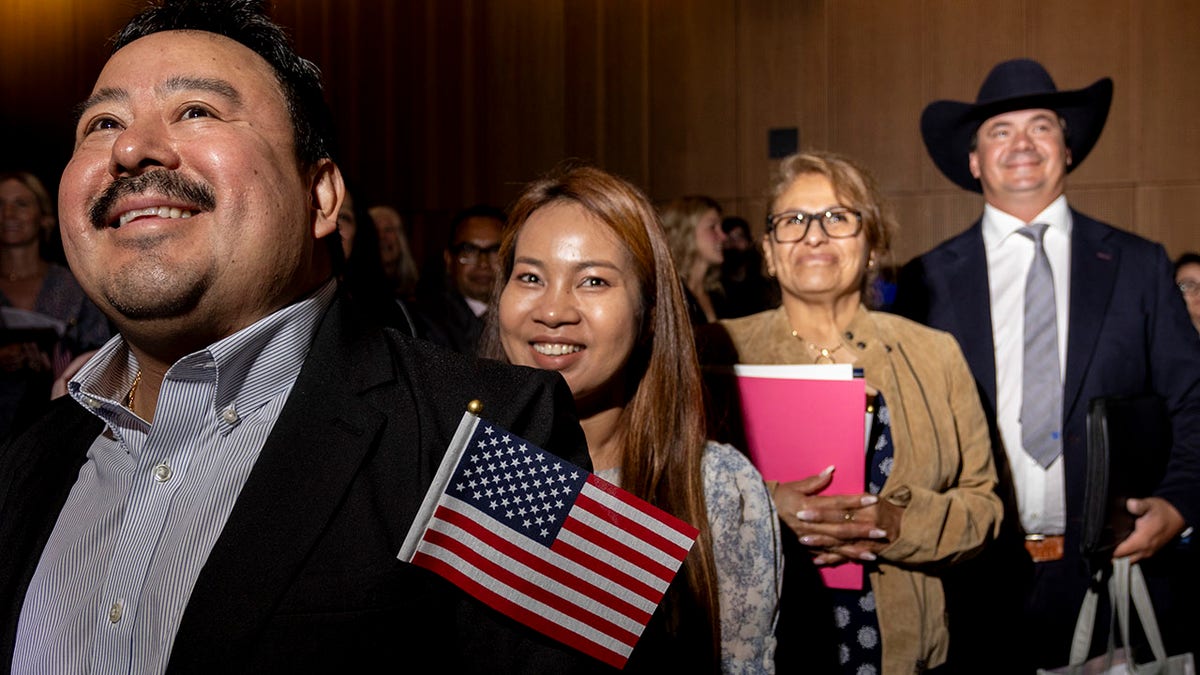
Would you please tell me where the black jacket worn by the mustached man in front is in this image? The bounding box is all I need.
[0,293,607,673]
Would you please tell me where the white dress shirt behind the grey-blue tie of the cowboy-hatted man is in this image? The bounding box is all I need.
[983,195,1072,534]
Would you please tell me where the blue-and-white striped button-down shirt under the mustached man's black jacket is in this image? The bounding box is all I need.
[12,281,336,675]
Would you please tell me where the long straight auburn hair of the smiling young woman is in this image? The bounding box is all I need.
[482,165,720,663]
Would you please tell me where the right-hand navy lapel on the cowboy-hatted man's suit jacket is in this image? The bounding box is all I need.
[1063,209,1121,420]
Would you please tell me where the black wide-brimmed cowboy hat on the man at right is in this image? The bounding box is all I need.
[920,59,1112,192]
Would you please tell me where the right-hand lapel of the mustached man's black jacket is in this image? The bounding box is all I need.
[173,291,416,658]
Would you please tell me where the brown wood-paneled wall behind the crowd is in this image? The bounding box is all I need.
[0,0,1200,270]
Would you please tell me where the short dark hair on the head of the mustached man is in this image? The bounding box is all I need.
[112,0,334,167]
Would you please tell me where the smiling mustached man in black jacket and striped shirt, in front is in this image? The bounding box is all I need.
[0,0,595,673]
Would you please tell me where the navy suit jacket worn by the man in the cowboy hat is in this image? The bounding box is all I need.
[894,210,1200,542]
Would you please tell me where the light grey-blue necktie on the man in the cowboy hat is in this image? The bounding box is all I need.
[1019,222,1062,467]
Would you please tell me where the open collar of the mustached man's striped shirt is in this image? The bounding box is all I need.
[67,280,337,420]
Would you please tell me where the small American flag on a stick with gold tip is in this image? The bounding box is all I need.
[398,412,697,668]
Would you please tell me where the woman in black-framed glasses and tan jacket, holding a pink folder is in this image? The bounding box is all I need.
[703,153,1002,674]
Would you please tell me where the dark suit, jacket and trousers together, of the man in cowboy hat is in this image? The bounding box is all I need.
[893,210,1200,674]
